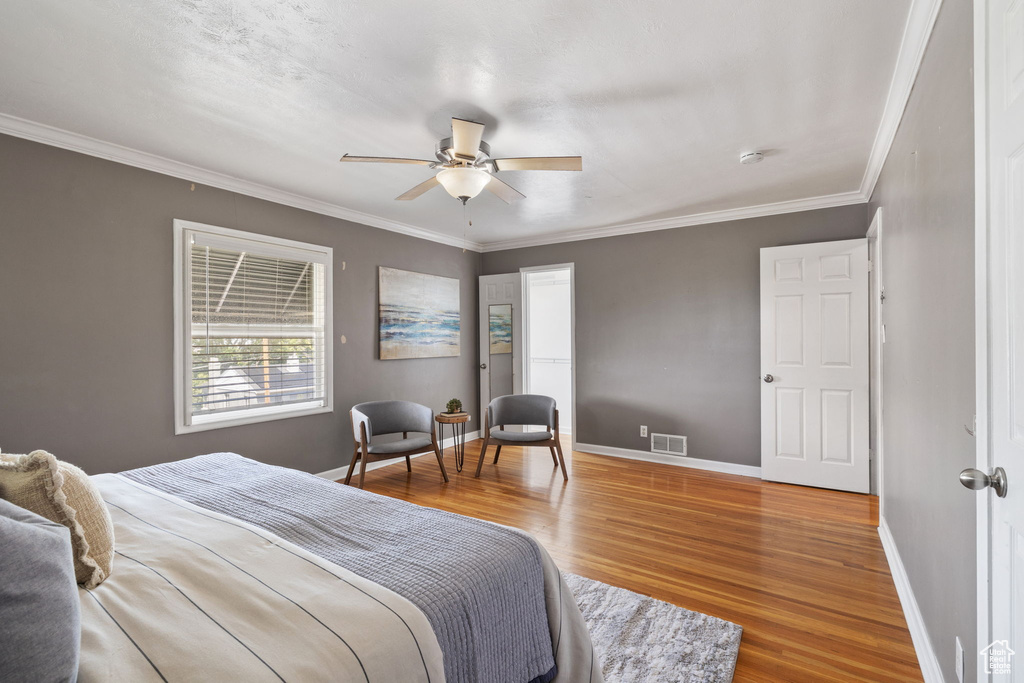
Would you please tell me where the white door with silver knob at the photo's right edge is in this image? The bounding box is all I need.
[976,0,1024,682]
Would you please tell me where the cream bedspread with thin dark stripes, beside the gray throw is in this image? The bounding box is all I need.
[79,474,444,682]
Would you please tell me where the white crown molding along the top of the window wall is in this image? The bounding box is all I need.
[0,114,481,252]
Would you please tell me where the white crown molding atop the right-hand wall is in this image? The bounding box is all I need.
[860,0,942,201]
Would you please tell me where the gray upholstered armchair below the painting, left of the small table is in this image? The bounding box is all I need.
[345,400,449,488]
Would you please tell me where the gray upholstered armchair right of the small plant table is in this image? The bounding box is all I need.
[476,393,569,481]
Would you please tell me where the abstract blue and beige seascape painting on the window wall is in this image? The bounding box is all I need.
[378,267,462,360]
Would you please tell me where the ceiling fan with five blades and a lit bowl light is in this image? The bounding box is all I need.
[341,118,583,205]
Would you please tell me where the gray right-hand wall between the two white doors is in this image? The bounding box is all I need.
[871,2,984,681]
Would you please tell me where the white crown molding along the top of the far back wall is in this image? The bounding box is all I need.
[481,191,867,253]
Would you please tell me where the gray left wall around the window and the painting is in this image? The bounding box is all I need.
[0,135,480,476]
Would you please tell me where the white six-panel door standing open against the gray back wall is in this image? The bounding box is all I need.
[752,240,870,494]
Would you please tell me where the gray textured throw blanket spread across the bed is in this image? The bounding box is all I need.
[121,453,555,683]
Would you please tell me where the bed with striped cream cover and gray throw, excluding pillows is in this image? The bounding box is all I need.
[79,454,602,683]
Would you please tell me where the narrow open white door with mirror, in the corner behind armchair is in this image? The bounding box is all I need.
[478,272,522,421]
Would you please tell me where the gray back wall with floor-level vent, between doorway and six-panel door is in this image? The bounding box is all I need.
[483,205,867,465]
